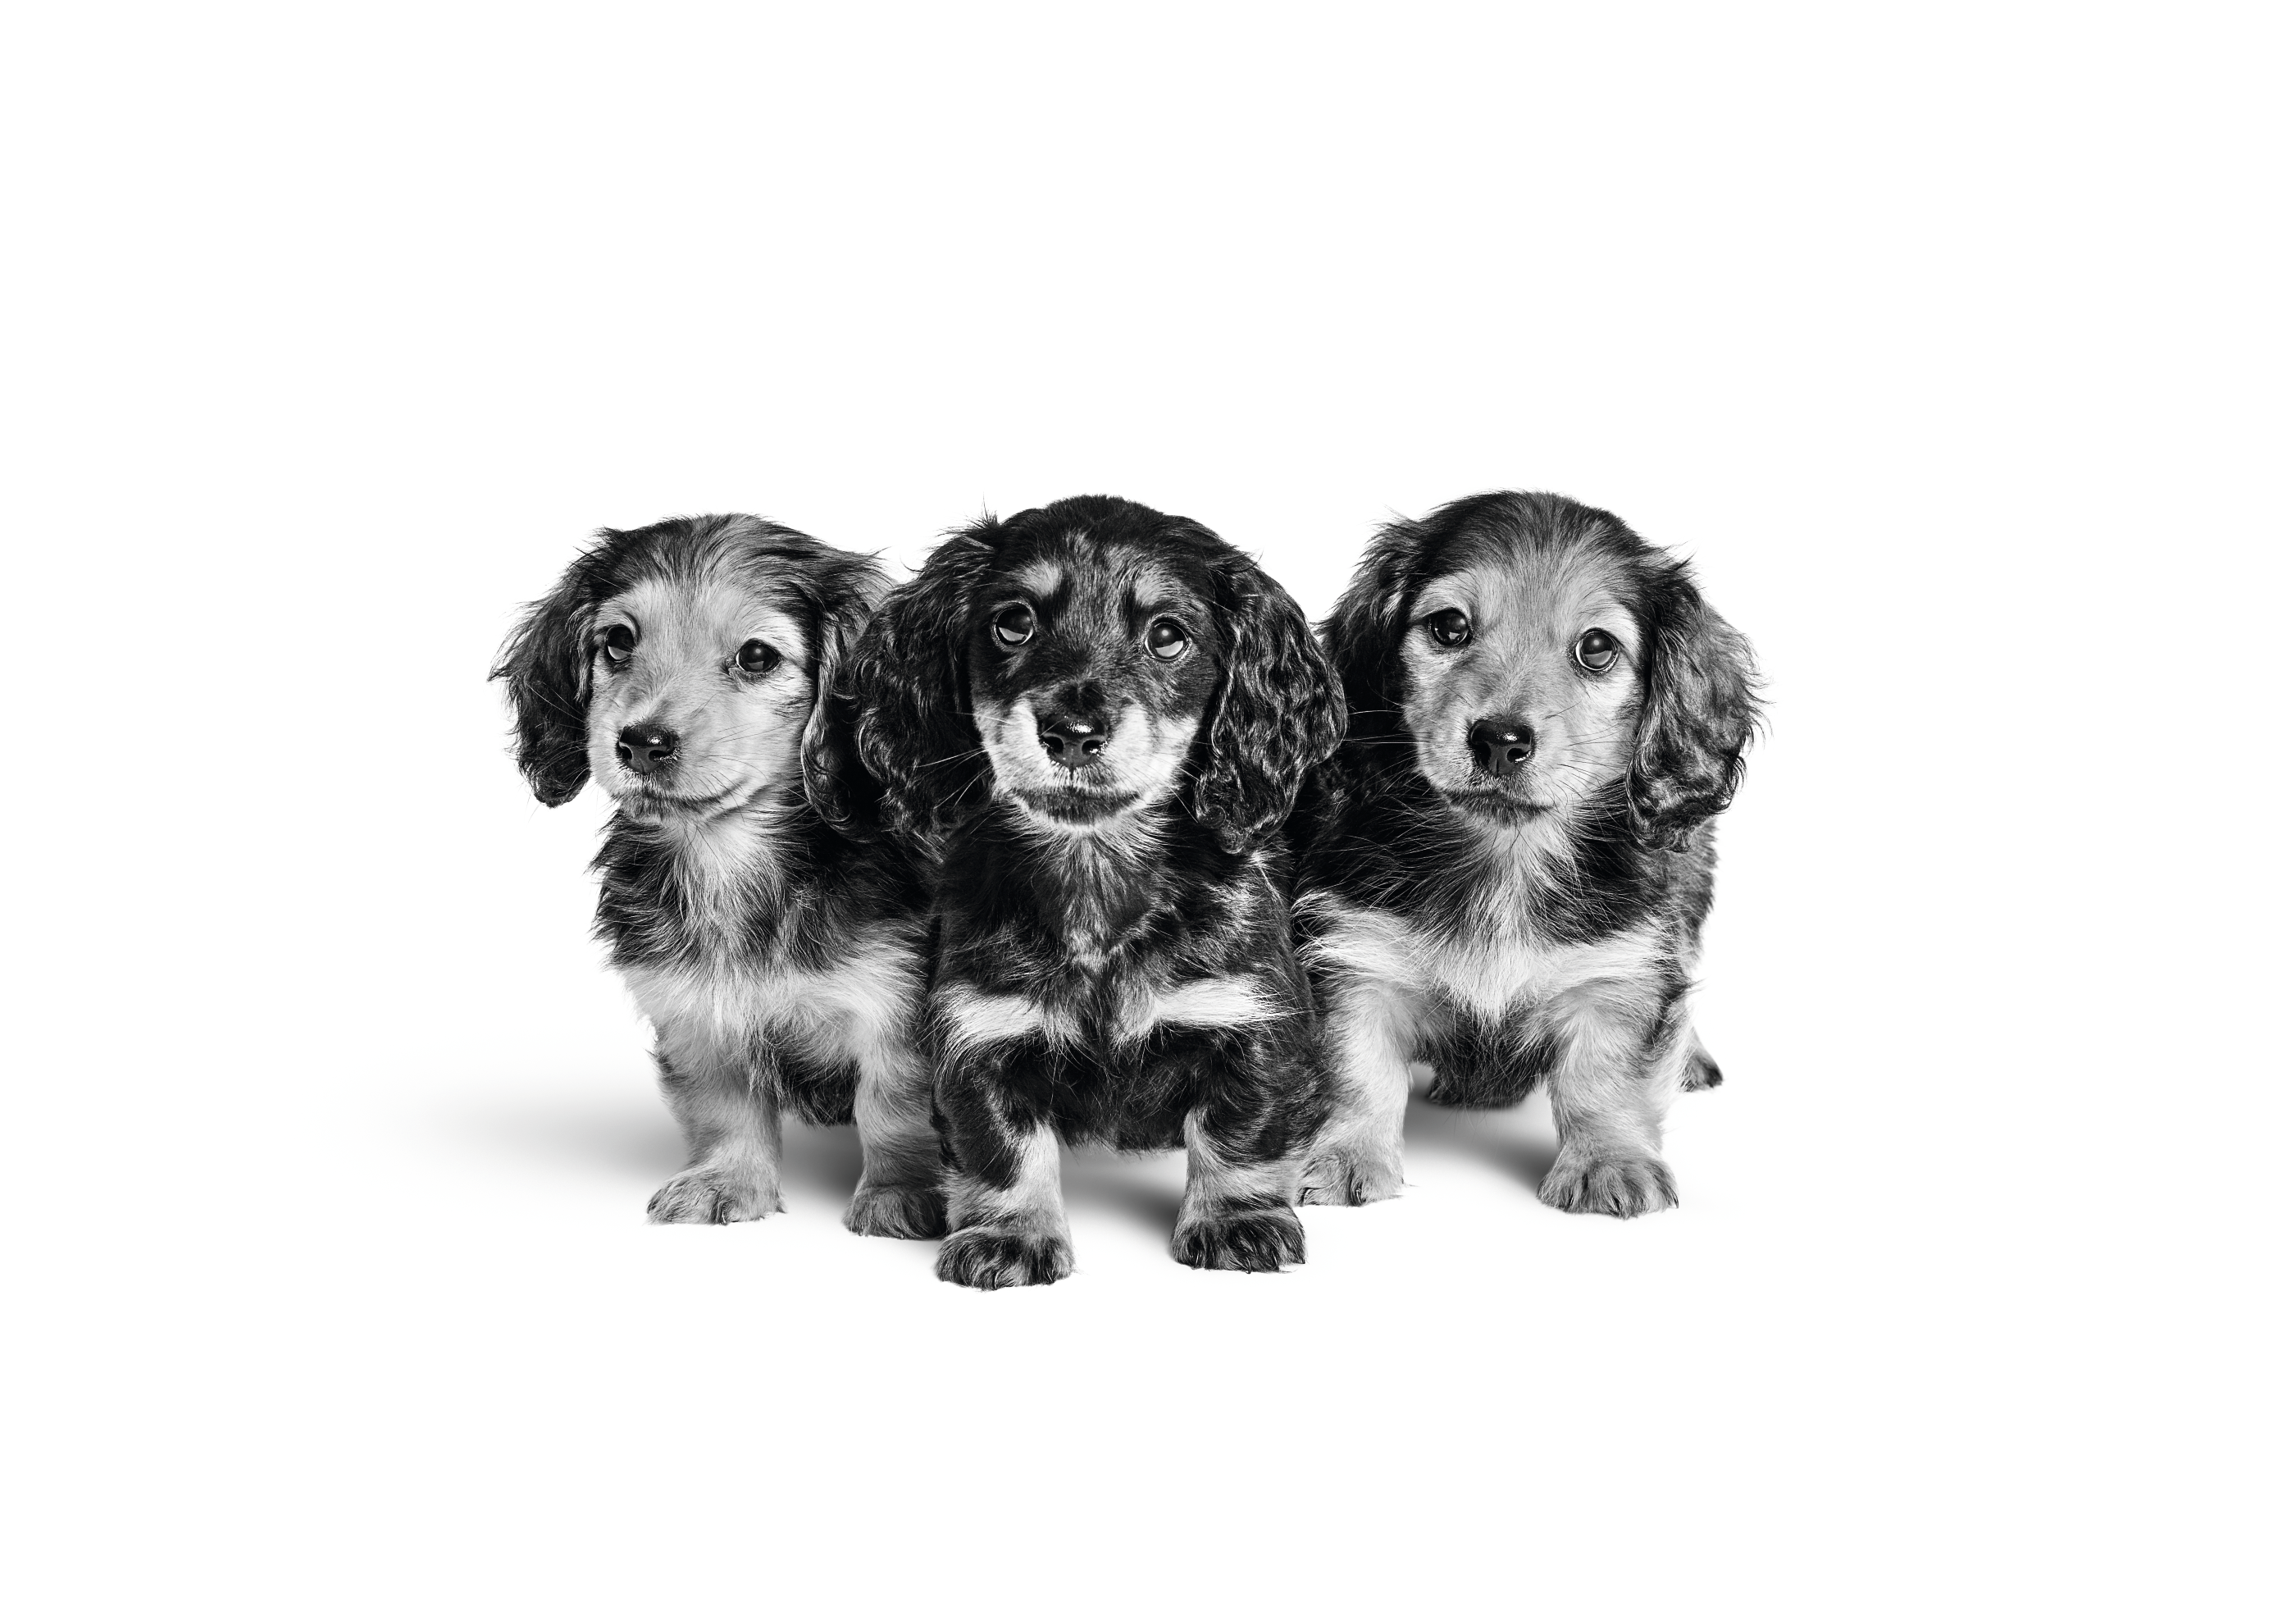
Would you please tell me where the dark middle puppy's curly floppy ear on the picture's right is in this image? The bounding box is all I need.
[1189,556,1348,852]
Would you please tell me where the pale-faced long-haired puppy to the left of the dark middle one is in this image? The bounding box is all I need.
[494,514,946,1236]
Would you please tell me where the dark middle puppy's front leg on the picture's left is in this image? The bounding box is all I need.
[935,1041,1077,1291]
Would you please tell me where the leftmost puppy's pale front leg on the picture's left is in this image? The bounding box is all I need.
[645,1022,781,1225]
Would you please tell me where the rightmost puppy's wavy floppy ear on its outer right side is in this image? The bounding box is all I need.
[1628,560,1761,852]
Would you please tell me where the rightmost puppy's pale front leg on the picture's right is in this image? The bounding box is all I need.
[1538,999,1690,1217]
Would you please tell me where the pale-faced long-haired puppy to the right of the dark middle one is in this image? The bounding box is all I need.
[1295,491,1756,1217]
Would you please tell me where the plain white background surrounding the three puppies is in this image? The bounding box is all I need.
[0,5,2296,1619]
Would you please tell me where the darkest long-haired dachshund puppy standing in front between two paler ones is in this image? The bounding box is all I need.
[856,496,1343,1289]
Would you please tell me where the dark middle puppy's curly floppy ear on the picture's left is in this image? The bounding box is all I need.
[852,519,999,852]
